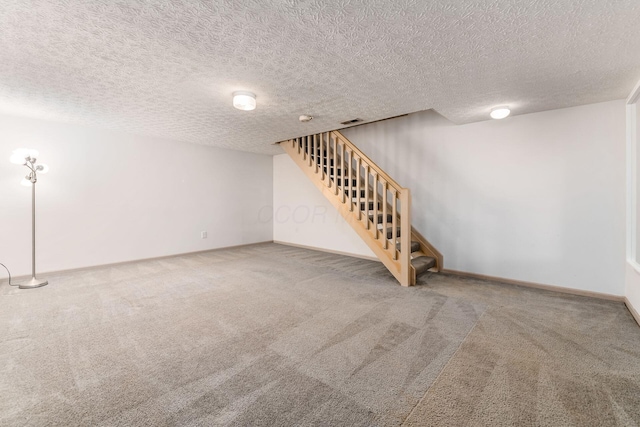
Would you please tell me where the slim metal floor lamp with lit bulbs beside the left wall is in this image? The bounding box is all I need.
[10,148,49,289]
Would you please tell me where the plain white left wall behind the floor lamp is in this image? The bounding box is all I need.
[0,116,273,278]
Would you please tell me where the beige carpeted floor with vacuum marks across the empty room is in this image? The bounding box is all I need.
[0,244,640,426]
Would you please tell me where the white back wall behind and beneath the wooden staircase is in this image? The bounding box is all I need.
[274,101,625,295]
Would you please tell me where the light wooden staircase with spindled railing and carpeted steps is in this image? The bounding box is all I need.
[280,131,442,286]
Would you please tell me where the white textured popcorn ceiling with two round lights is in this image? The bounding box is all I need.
[0,0,640,154]
